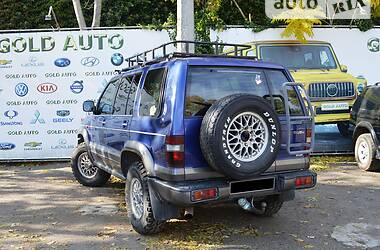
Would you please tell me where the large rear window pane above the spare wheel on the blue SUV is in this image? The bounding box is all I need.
[185,67,269,116]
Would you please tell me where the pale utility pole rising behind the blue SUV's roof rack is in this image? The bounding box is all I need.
[177,0,194,53]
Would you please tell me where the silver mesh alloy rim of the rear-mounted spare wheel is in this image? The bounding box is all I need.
[227,112,269,162]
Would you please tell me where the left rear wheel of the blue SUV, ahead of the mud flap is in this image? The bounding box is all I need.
[125,162,164,235]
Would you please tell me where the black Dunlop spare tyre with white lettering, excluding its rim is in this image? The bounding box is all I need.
[209,96,281,179]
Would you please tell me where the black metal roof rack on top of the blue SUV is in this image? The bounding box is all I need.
[123,41,257,71]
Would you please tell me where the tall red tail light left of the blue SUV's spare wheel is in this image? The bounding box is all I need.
[165,136,185,168]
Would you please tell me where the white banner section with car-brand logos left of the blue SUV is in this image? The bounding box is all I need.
[0,29,170,160]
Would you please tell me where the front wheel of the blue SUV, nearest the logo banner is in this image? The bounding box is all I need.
[71,143,111,187]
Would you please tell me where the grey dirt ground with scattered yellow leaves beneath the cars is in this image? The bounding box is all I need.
[0,159,380,249]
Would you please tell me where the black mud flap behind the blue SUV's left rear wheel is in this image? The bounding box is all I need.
[148,182,181,221]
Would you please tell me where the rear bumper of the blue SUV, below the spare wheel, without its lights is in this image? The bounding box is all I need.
[148,170,317,207]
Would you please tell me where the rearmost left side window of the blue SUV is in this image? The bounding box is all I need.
[140,68,165,116]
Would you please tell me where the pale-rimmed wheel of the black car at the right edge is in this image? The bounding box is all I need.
[355,133,380,171]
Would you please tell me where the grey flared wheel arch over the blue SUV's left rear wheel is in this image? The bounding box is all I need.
[120,141,155,177]
